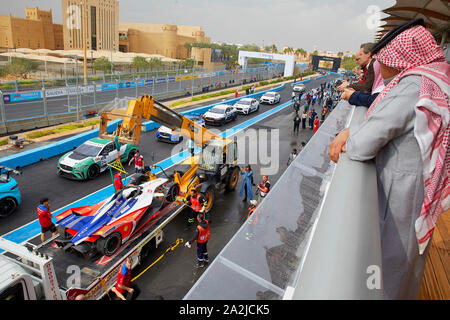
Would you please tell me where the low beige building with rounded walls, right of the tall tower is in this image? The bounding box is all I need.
[119,22,213,67]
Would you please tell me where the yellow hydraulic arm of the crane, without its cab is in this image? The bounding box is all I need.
[100,95,231,147]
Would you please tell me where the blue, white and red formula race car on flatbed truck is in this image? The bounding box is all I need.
[55,178,179,258]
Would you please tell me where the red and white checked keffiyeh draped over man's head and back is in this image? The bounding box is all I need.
[366,26,450,254]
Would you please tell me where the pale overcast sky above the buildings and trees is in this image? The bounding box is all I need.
[0,0,395,52]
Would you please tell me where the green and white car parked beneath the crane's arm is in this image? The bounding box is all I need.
[58,138,137,180]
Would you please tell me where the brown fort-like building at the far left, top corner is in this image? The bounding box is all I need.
[0,7,64,50]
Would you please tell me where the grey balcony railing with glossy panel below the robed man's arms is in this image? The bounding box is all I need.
[184,101,383,300]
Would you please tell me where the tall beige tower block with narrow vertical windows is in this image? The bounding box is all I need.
[62,0,119,51]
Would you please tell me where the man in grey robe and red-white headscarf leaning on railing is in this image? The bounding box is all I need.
[328,19,450,299]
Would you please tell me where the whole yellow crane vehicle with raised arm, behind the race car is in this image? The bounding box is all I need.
[100,95,240,212]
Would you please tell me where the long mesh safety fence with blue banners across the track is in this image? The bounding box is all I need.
[0,67,279,127]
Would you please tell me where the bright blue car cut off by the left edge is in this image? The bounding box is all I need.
[0,166,22,218]
